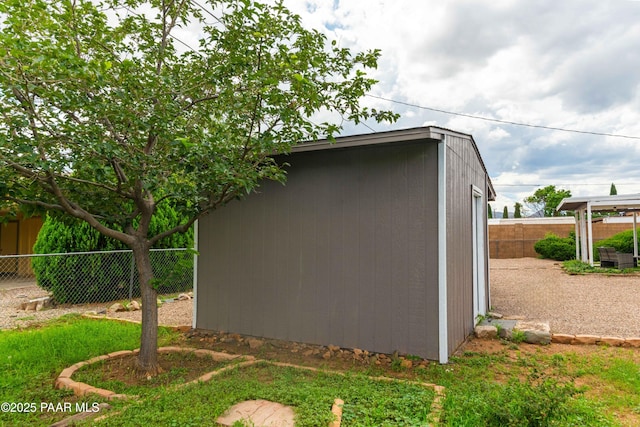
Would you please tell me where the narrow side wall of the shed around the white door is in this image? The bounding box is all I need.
[447,136,489,353]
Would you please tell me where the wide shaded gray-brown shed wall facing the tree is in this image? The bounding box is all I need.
[196,141,438,359]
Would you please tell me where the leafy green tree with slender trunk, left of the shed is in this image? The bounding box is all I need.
[0,0,398,375]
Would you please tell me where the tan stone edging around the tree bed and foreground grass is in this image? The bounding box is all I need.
[55,346,445,427]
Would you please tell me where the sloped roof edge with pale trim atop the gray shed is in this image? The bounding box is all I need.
[291,126,496,200]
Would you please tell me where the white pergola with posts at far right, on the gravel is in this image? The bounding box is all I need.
[556,194,640,265]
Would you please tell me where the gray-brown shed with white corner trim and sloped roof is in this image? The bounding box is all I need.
[193,127,495,363]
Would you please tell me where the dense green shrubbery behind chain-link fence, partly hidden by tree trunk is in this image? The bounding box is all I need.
[32,208,193,304]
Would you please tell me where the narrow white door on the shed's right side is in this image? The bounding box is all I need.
[471,186,487,319]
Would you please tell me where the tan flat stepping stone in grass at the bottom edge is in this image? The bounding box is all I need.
[216,400,295,427]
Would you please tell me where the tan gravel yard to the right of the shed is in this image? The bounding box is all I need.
[490,258,640,338]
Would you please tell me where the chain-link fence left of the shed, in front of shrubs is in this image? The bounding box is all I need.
[0,248,194,304]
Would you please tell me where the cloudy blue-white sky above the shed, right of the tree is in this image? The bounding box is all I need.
[276,0,640,212]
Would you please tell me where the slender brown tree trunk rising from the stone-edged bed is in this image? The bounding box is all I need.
[133,243,161,376]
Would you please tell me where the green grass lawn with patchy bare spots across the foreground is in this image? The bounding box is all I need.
[0,316,640,426]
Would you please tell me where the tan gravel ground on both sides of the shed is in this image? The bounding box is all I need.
[0,258,640,338]
